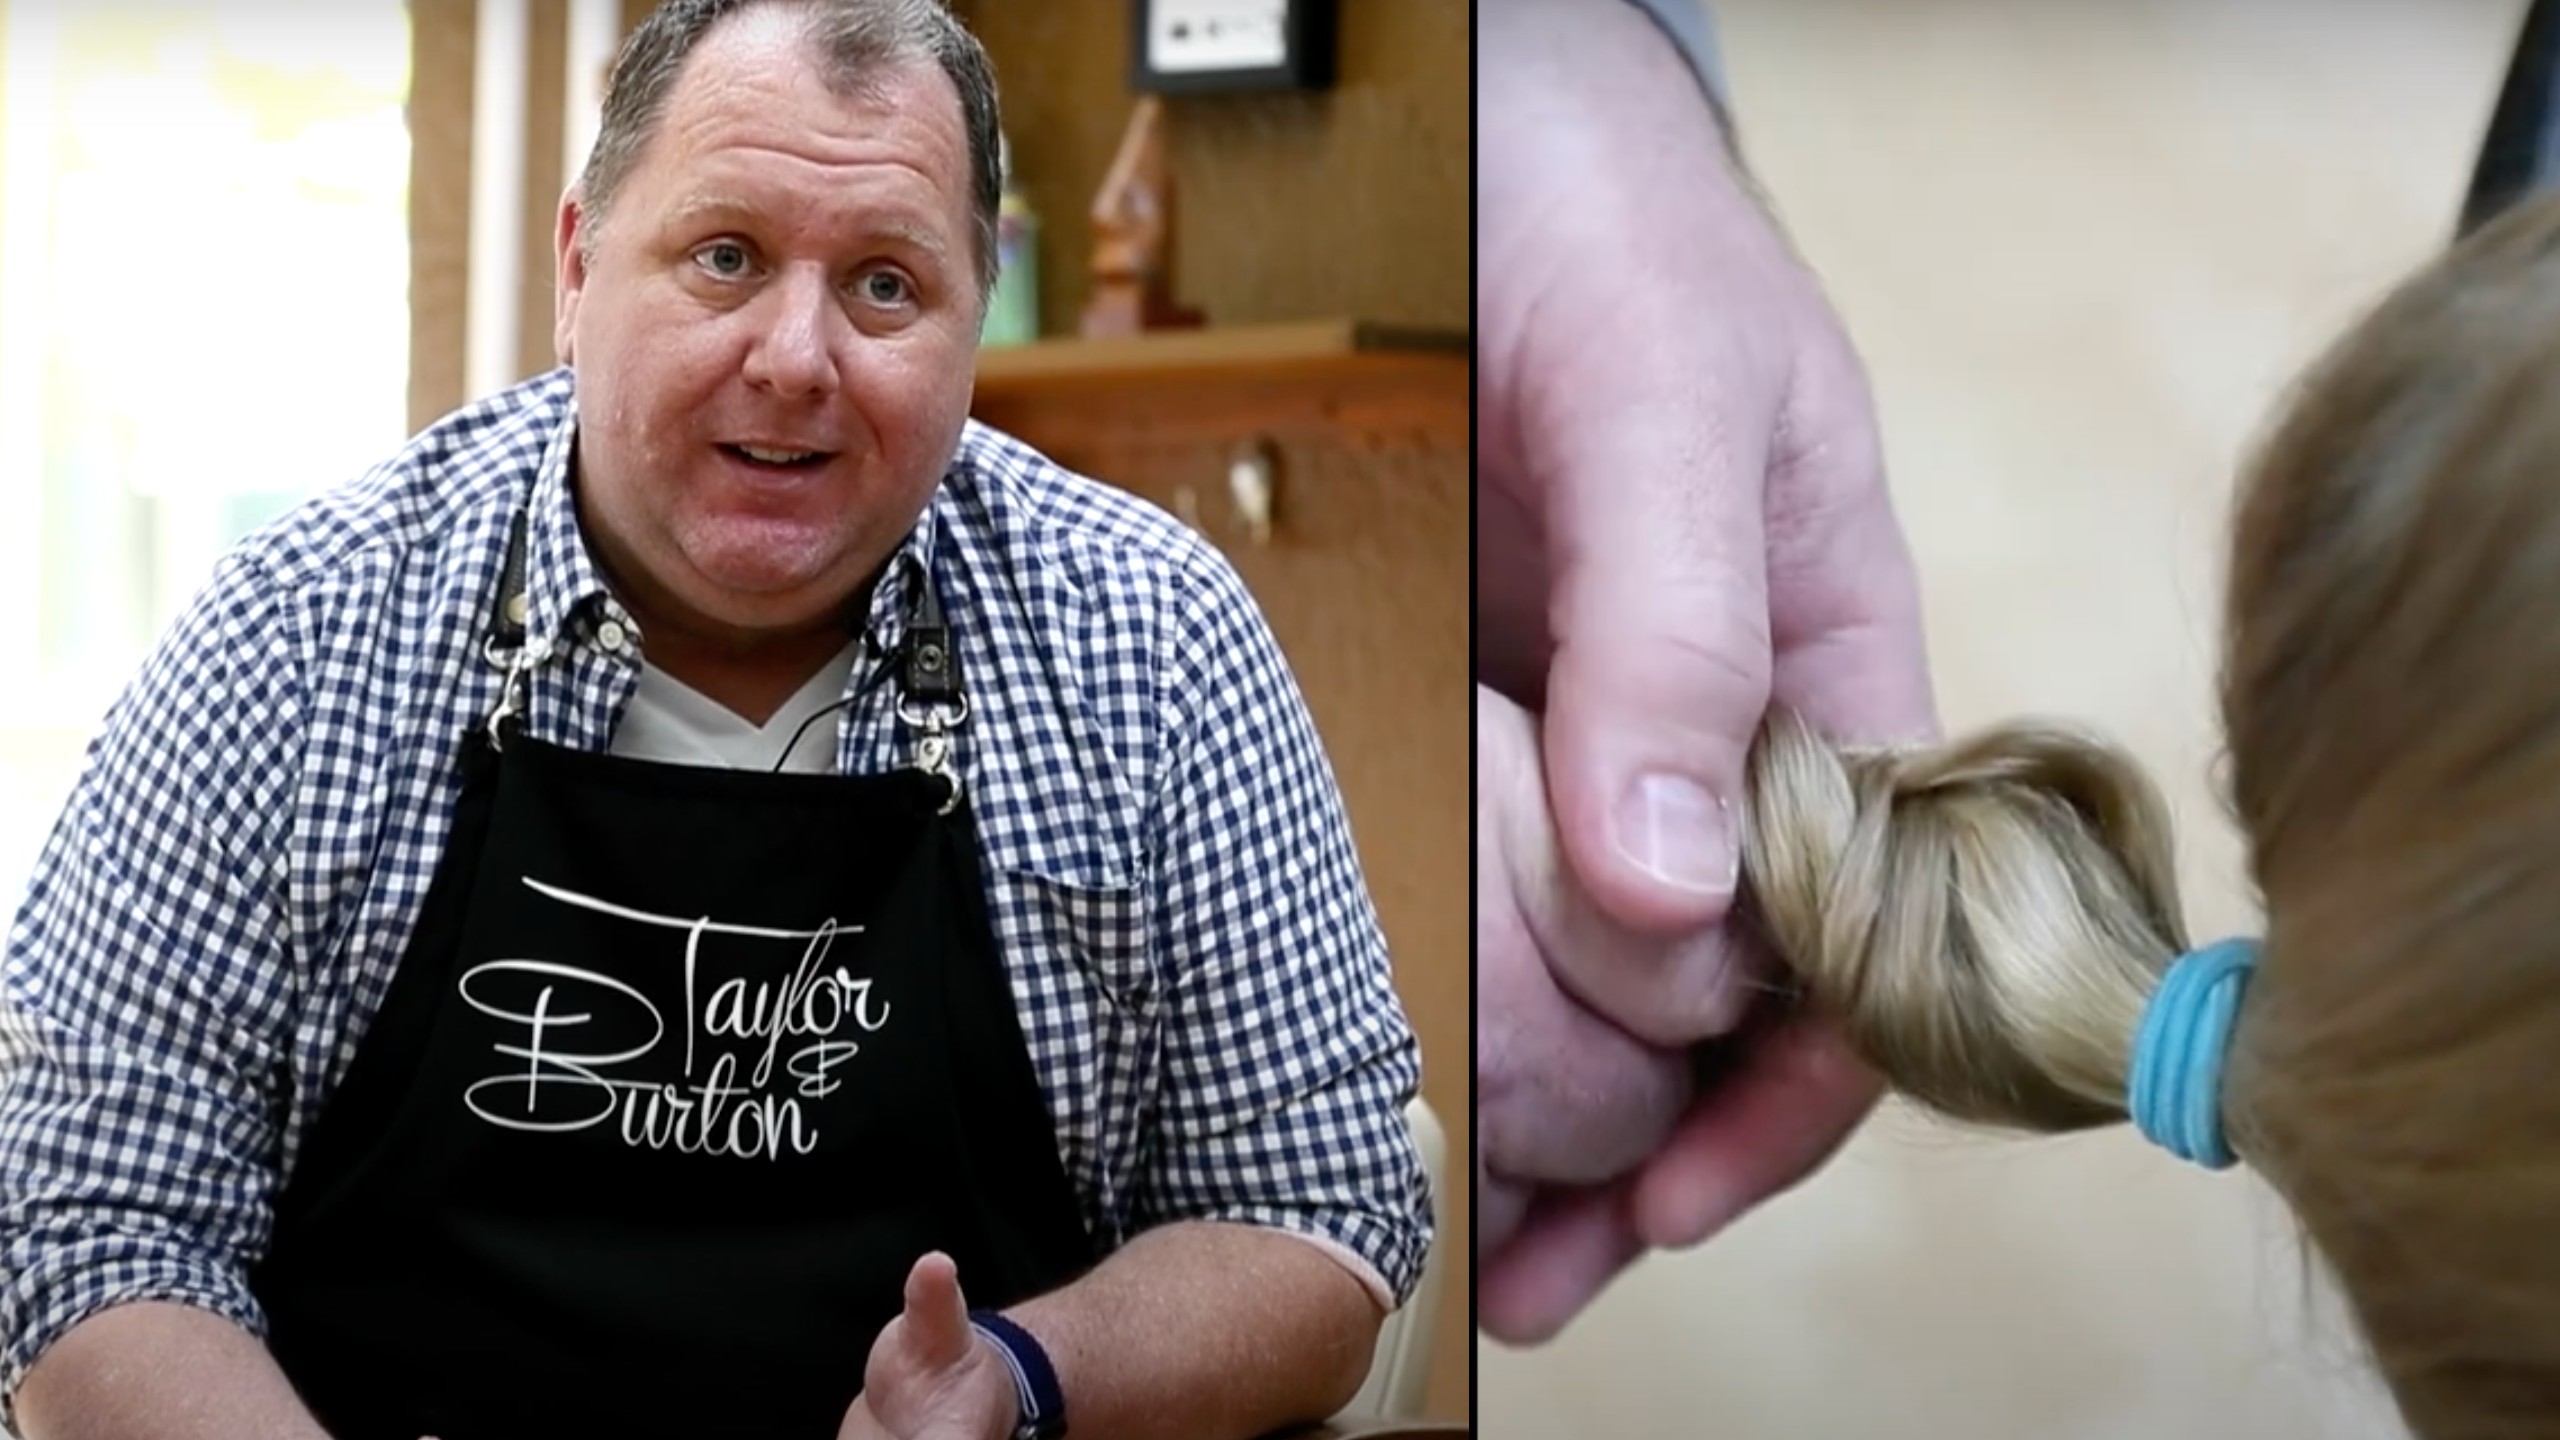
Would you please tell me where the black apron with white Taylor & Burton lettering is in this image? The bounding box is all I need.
[251,518,1096,1440]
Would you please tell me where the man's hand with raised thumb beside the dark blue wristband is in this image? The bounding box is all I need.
[835,1253,1019,1440]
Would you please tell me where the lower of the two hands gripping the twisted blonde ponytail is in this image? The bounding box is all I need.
[1475,687,1871,1343]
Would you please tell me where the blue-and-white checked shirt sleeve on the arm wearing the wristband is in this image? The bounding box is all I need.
[1134,545,1431,1307]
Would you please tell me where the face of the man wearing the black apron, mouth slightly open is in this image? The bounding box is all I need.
[558,8,980,643]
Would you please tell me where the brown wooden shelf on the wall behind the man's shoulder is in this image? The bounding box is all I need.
[978,320,1472,405]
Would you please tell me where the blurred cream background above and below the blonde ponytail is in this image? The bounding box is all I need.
[1477,0,2524,1440]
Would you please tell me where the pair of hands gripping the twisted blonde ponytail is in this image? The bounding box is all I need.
[1477,0,1935,1343]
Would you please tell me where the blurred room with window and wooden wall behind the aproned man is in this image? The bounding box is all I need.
[0,0,1472,1420]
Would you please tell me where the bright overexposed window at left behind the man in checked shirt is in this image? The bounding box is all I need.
[0,0,410,915]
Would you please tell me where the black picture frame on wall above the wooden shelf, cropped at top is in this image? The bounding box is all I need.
[1129,0,1336,95]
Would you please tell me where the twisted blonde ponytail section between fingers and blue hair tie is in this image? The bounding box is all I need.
[1743,712,2186,1133]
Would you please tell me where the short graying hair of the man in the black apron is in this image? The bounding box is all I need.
[579,0,1004,300]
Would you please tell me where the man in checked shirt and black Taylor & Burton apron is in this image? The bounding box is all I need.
[0,0,1428,1440]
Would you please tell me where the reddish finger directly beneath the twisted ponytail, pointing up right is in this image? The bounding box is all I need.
[1631,1010,1879,1250]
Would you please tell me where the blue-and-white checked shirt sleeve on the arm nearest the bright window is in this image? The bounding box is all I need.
[0,564,300,1417]
